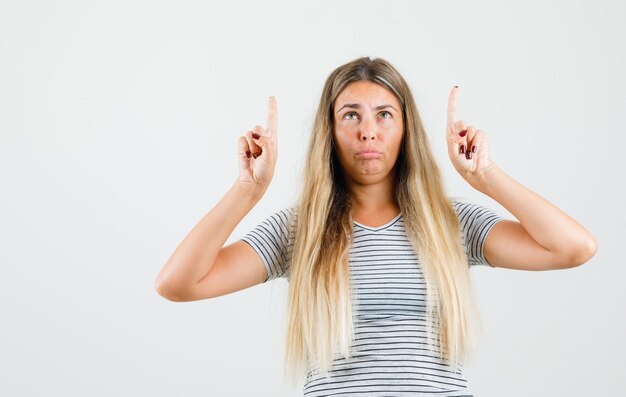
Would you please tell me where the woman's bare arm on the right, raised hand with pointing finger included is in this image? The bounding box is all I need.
[446,86,598,270]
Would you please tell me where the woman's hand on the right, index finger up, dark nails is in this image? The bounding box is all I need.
[446,86,494,182]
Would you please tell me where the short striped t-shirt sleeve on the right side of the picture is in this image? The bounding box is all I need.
[453,200,504,267]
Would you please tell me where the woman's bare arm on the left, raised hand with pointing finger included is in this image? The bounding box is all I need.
[155,97,278,301]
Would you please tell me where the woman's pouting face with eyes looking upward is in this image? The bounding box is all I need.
[333,81,403,185]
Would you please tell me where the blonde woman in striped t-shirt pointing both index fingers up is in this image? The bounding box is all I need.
[156,57,597,396]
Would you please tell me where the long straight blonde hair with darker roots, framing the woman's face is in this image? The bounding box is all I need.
[285,57,478,383]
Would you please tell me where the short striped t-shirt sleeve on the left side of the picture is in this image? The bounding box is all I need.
[241,207,296,283]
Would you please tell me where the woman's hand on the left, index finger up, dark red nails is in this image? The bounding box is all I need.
[237,96,278,191]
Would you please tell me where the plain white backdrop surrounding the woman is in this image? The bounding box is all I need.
[0,0,626,397]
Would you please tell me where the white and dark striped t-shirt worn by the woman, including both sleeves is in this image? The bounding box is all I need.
[242,199,502,397]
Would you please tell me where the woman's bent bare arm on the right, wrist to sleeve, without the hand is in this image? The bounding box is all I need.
[466,162,598,270]
